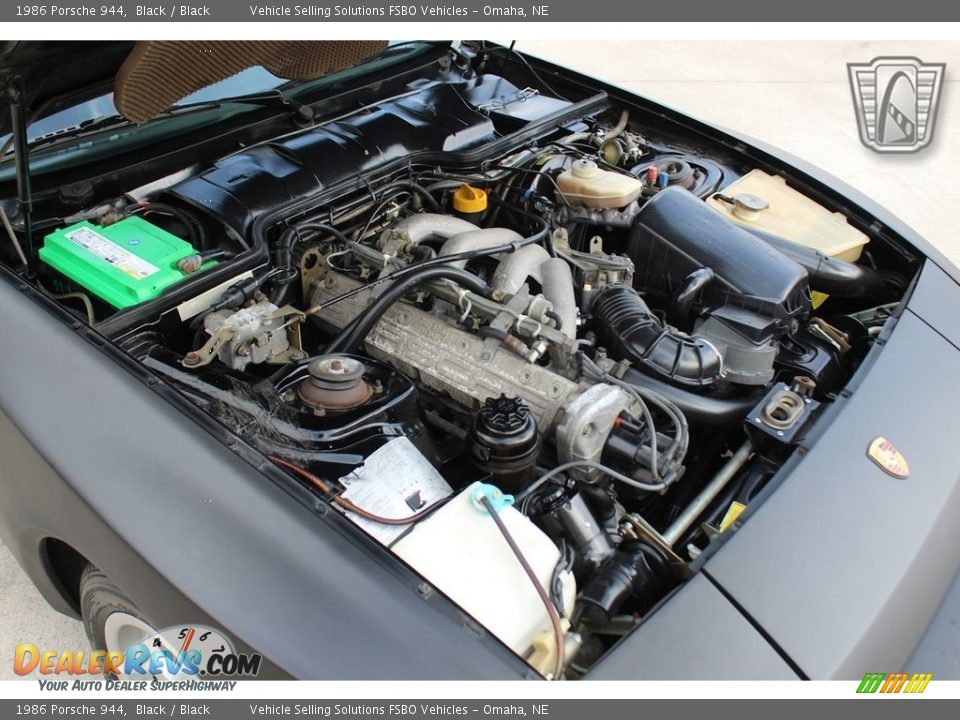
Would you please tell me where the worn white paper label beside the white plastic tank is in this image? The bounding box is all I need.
[340,437,453,545]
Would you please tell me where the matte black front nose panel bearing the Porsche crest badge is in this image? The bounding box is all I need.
[705,298,960,679]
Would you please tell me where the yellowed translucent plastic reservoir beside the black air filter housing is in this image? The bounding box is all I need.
[707,170,869,262]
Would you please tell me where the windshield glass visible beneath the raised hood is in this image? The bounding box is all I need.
[0,42,435,181]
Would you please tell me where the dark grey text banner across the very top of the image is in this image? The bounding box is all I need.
[0,0,960,23]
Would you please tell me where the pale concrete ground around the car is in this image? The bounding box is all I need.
[0,39,960,679]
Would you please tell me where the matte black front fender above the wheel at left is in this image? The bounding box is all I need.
[0,282,530,679]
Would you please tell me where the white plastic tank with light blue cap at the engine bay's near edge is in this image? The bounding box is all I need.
[391,483,577,655]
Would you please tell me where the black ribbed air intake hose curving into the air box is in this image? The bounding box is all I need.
[593,285,722,387]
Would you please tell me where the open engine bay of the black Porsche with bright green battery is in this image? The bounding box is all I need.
[5,47,919,679]
